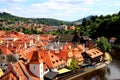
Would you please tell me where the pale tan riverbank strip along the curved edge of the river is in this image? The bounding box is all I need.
[66,61,110,80]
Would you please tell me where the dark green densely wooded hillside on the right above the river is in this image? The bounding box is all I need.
[80,12,120,38]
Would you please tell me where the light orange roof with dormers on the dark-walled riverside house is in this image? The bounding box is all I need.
[86,48,103,58]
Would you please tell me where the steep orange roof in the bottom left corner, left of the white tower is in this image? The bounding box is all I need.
[0,61,40,80]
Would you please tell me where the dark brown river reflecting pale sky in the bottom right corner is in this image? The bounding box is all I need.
[73,49,120,80]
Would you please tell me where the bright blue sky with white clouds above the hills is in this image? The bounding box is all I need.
[0,0,120,21]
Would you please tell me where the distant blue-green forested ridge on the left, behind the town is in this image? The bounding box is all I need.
[0,12,73,26]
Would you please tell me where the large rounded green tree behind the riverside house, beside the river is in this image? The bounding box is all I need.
[96,37,111,52]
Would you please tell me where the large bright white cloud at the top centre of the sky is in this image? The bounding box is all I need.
[31,0,92,12]
